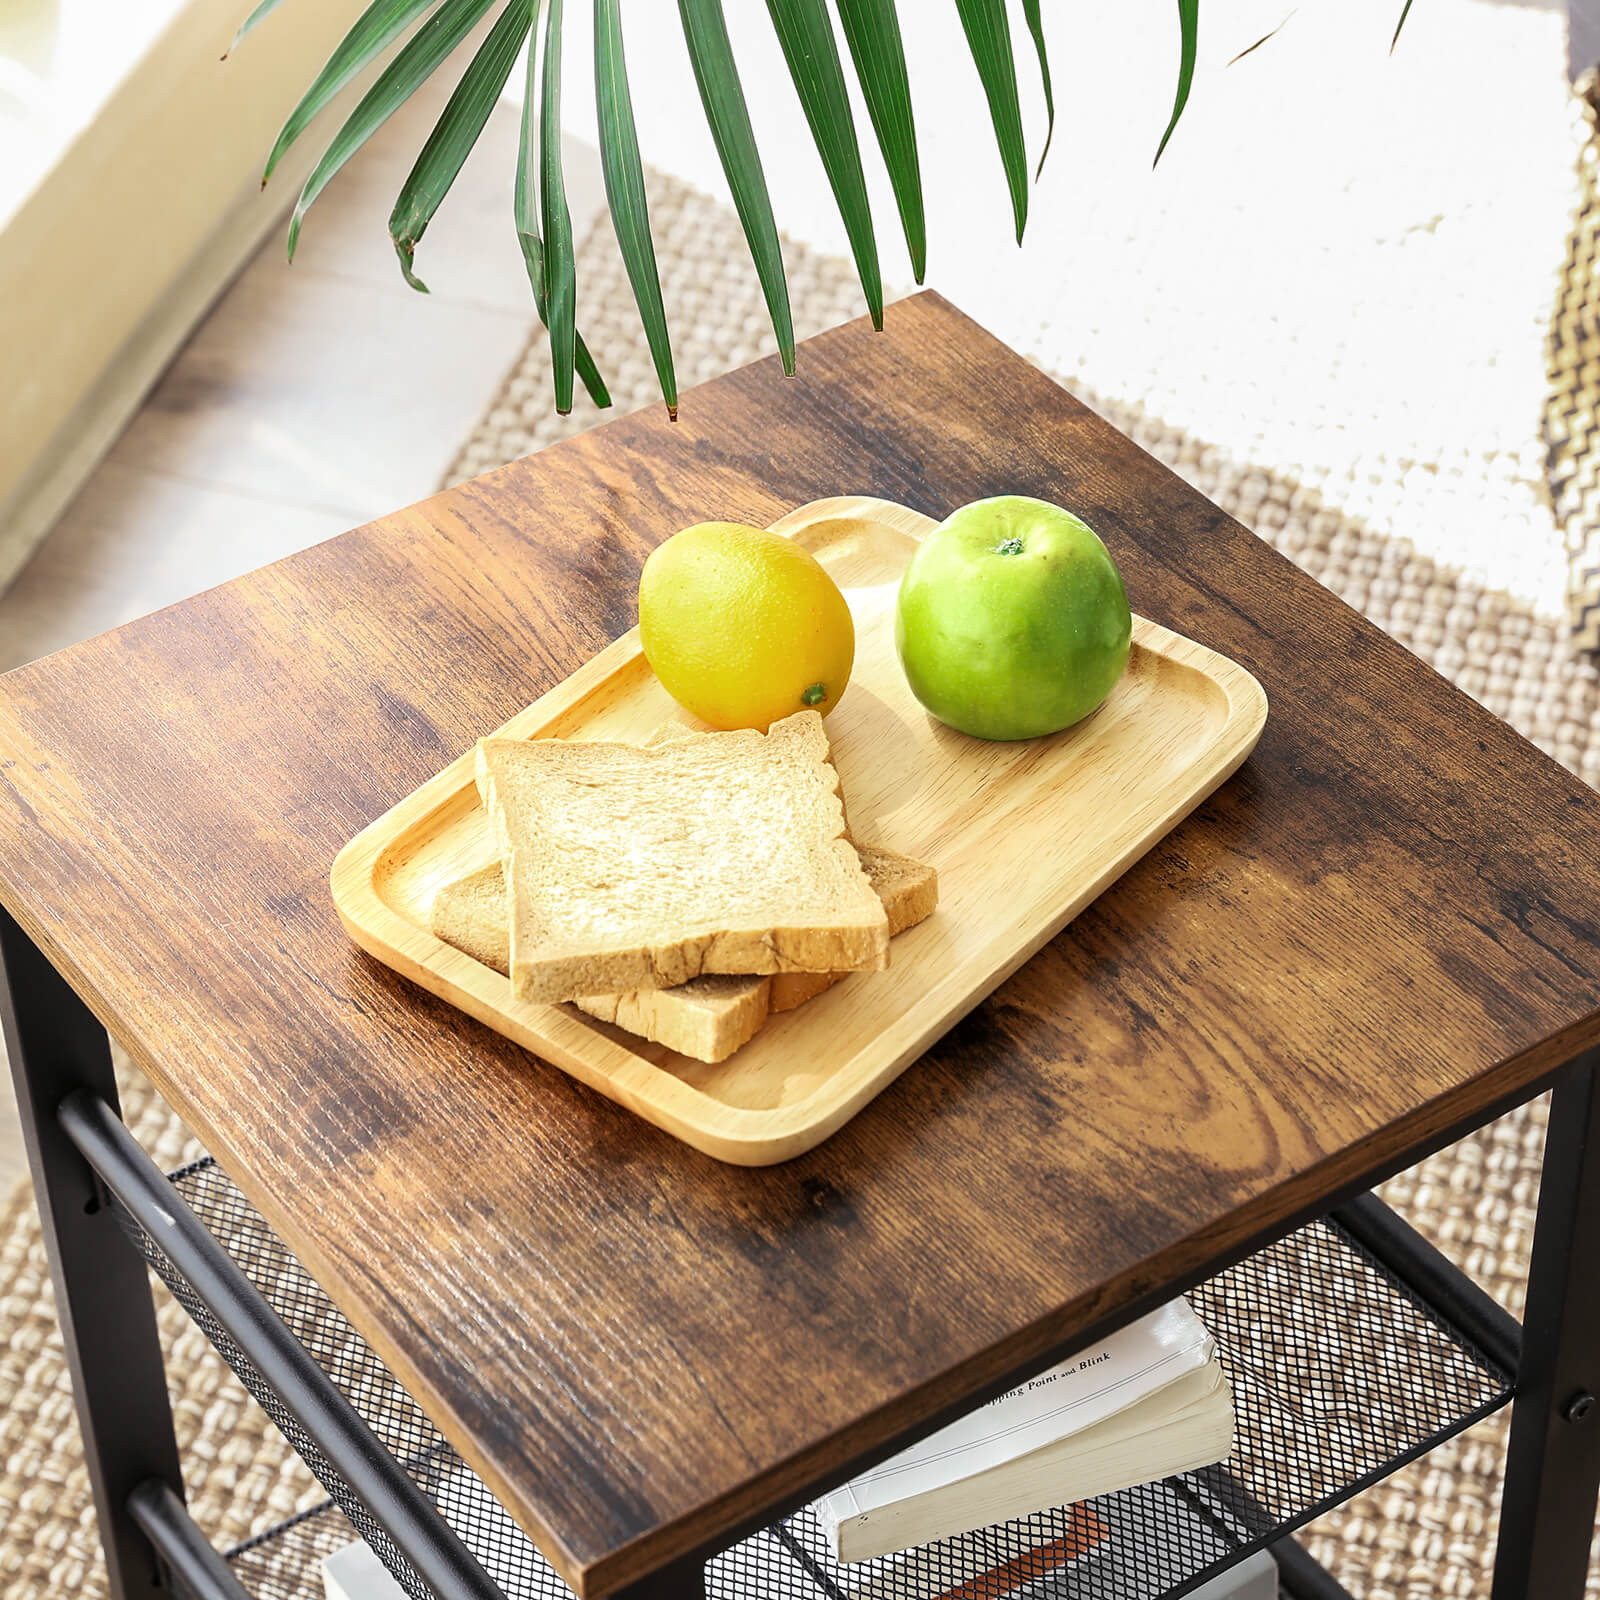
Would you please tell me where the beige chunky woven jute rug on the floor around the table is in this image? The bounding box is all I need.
[0,168,1600,1600]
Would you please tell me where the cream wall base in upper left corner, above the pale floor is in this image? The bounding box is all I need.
[0,0,374,586]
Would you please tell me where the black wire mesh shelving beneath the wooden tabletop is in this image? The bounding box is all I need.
[125,1160,1510,1600]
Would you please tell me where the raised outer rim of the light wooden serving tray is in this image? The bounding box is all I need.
[330,494,1267,1166]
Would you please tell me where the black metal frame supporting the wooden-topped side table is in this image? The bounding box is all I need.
[12,889,1600,1600]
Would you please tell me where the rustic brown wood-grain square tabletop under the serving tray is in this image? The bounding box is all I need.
[0,294,1600,1595]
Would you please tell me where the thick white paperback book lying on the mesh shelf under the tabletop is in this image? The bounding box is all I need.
[816,1299,1234,1562]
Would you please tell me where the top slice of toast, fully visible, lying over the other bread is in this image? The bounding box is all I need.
[477,712,890,1002]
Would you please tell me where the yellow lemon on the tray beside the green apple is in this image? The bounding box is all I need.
[638,522,856,731]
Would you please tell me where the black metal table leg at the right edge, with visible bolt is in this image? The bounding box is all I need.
[1493,1053,1600,1600]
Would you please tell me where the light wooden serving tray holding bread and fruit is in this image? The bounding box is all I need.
[333,498,1267,1166]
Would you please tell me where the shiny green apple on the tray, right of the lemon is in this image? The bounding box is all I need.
[894,494,1133,739]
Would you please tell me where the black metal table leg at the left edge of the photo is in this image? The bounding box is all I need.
[0,909,182,1600]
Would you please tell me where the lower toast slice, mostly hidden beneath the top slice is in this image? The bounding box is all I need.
[429,845,939,1061]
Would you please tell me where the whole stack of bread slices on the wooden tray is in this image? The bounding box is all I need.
[430,710,939,1061]
